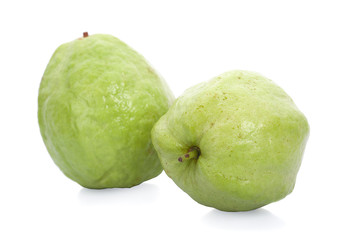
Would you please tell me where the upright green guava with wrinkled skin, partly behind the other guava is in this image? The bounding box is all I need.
[38,34,174,188]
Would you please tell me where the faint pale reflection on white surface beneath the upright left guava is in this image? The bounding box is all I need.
[78,183,159,205]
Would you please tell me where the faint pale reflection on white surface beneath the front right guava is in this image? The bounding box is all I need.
[202,208,285,231]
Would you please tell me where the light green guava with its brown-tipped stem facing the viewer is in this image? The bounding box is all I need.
[152,71,309,211]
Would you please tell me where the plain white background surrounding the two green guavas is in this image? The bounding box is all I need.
[0,0,349,239]
